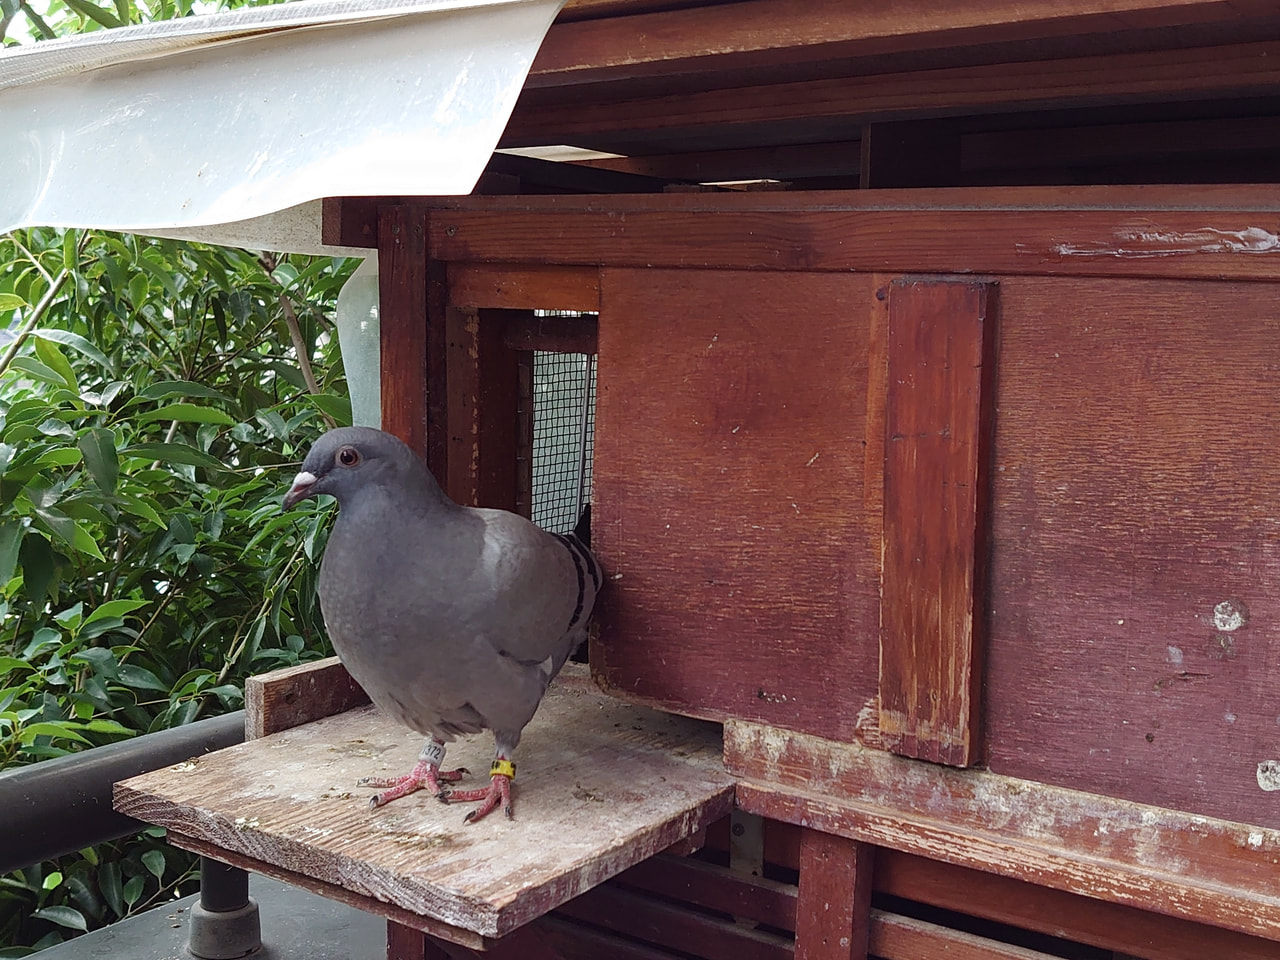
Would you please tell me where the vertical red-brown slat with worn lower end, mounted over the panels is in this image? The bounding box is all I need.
[879,280,995,767]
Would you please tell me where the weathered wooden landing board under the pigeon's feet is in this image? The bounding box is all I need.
[115,664,733,943]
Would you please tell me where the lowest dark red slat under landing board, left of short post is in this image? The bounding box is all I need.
[557,883,792,960]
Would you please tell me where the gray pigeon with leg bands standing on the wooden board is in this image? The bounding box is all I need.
[284,426,600,822]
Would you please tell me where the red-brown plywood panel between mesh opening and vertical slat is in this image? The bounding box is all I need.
[591,270,882,739]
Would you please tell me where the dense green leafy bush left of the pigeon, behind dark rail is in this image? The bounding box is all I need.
[0,229,353,956]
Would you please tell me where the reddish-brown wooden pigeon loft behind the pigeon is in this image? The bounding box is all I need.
[122,0,1280,960]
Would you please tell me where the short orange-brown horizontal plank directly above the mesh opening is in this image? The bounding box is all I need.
[448,264,600,314]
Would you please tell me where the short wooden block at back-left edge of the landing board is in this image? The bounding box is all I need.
[244,657,369,740]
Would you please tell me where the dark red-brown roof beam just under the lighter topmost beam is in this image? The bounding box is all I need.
[499,40,1280,145]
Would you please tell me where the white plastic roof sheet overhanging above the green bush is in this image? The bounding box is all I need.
[0,0,563,248]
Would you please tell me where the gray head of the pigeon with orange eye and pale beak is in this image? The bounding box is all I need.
[284,426,439,509]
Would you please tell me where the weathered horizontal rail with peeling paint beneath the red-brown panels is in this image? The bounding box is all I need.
[724,721,1280,940]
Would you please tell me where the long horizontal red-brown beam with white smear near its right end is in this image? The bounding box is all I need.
[431,199,1280,279]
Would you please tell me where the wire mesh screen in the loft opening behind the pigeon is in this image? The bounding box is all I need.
[530,351,595,534]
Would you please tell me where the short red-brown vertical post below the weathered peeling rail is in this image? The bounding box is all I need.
[795,829,876,960]
